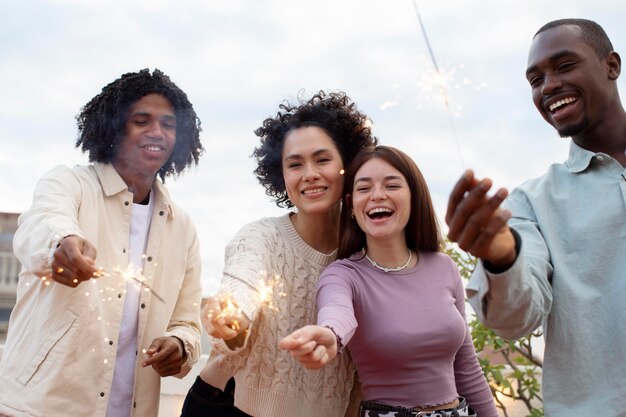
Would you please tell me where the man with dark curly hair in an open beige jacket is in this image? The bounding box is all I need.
[0,69,202,417]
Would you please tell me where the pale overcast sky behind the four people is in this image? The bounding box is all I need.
[0,0,626,294]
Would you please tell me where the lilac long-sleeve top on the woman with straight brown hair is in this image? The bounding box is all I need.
[317,252,497,417]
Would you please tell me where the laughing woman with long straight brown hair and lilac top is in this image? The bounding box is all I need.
[279,146,497,417]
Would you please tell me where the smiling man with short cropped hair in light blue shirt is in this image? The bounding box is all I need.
[446,19,626,417]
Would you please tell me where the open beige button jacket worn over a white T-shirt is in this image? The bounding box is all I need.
[0,164,202,417]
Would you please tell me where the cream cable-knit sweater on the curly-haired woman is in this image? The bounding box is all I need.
[200,215,354,417]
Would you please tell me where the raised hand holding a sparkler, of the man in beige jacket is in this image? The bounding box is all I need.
[51,236,98,287]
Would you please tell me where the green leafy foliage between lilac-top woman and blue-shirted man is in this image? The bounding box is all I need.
[444,242,543,417]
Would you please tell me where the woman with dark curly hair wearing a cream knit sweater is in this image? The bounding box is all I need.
[182,91,377,417]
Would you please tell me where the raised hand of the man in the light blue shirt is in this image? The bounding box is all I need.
[446,171,517,269]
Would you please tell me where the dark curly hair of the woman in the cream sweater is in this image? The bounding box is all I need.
[251,91,378,208]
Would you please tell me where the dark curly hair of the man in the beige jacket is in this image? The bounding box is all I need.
[76,69,204,180]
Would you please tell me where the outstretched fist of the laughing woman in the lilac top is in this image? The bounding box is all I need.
[278,325,337,369]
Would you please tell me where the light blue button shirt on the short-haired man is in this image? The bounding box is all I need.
[467,142,626,417]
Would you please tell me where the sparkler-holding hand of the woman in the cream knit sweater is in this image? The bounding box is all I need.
[201,295,250,340]
